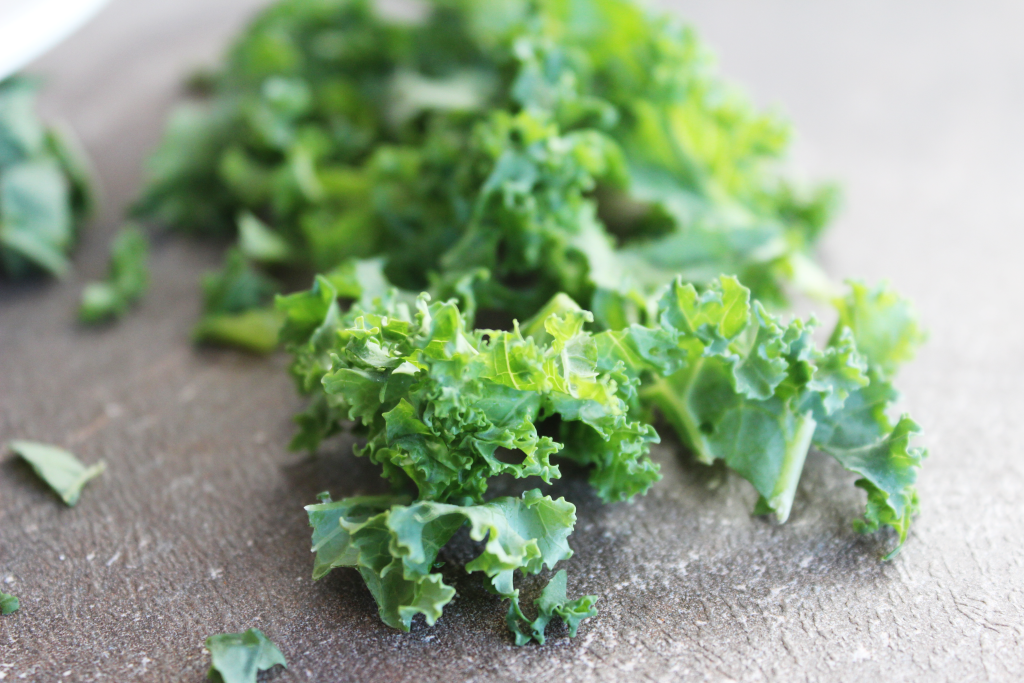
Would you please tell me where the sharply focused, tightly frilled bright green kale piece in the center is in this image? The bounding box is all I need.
[279,278,658,501]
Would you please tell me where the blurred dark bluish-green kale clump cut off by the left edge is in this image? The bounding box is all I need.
[0,76,92,279]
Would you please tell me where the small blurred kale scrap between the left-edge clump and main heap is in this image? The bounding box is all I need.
[79,225,150,324]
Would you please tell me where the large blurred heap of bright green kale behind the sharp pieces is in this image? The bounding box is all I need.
[137,0,835,352]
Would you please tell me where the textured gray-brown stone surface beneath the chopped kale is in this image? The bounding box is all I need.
[0,0,1024,683]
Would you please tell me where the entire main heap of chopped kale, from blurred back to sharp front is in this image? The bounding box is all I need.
[148,0,925,644]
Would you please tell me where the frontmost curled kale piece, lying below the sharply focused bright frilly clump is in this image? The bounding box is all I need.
[306,489,596,642]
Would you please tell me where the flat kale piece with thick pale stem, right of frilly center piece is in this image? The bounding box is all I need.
[618,278,924,532]
